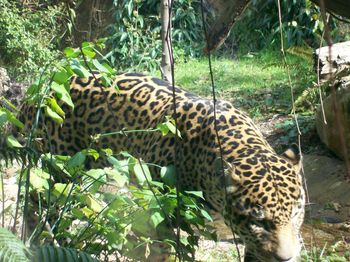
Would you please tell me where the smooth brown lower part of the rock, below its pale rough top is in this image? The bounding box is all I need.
[316,82,350,160]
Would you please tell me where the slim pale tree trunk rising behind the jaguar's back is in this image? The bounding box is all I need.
[160,0,173,84]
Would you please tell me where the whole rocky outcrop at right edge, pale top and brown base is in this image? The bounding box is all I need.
[315,41,350,161]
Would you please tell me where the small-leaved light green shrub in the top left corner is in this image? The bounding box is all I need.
[0,0,69,80]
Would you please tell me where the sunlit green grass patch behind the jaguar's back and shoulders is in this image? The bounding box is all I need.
[175,51,316,117]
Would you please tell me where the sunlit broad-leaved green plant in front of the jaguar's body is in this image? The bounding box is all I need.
[0,42,215,261]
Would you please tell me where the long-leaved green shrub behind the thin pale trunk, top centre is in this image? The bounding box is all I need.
[107,0,203,71]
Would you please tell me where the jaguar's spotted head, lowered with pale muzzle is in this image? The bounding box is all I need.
[224,147,305,262]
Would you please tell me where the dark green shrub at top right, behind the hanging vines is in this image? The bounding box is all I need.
[230,0,334,51]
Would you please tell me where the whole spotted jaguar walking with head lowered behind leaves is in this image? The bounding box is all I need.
[12,73,305,262]
